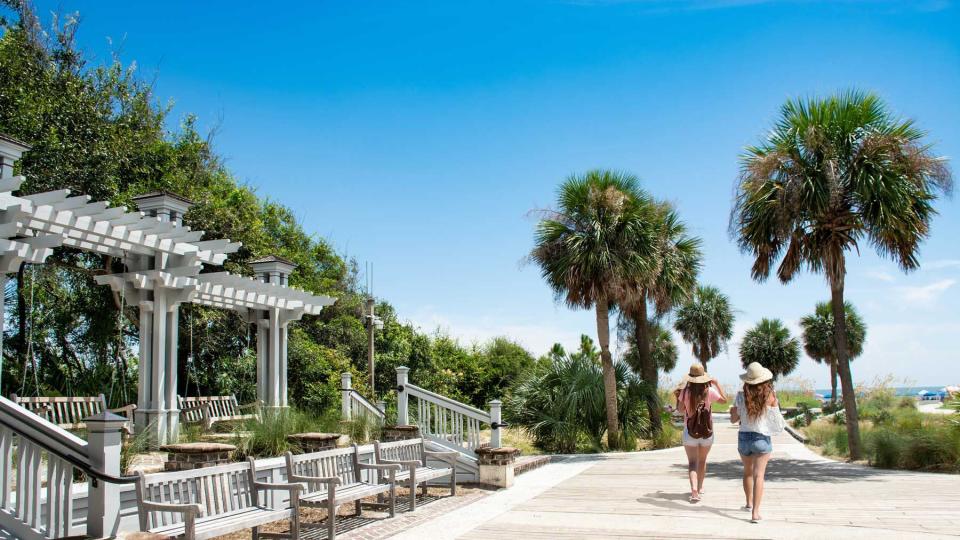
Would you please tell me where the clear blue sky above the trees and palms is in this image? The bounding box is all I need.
[30,0,960,387]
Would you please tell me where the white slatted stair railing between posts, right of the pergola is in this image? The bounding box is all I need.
[397,367,506,455]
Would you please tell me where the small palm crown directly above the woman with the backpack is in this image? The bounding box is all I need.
[673,285,734,368]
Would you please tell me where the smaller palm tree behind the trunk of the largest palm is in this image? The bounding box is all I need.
[800,302,867,402]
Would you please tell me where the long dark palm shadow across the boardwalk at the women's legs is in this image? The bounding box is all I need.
[672,456,894,483]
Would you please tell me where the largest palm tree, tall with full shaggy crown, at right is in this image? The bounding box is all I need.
[730,91,953,459]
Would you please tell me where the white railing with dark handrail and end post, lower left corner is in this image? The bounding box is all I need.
[0,397,133,540]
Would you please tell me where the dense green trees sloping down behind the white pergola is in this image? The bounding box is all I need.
[0,3,533,414]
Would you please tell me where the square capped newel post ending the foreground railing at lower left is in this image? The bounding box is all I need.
[83,411,127,538]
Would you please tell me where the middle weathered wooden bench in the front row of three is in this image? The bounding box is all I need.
[287,444,400,540]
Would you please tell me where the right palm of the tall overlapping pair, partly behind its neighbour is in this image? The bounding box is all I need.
[621,202,703,436]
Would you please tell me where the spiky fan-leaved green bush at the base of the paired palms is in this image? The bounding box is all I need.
[504,355,654,453]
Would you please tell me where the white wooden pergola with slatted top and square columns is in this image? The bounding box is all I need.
[0,135,335,444]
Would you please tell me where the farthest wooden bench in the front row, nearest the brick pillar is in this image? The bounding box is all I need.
[373,439,457,510]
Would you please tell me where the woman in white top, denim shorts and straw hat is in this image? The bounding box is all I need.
[730,362,784,523]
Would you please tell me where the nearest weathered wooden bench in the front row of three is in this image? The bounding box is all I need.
[137,458,303,540]
